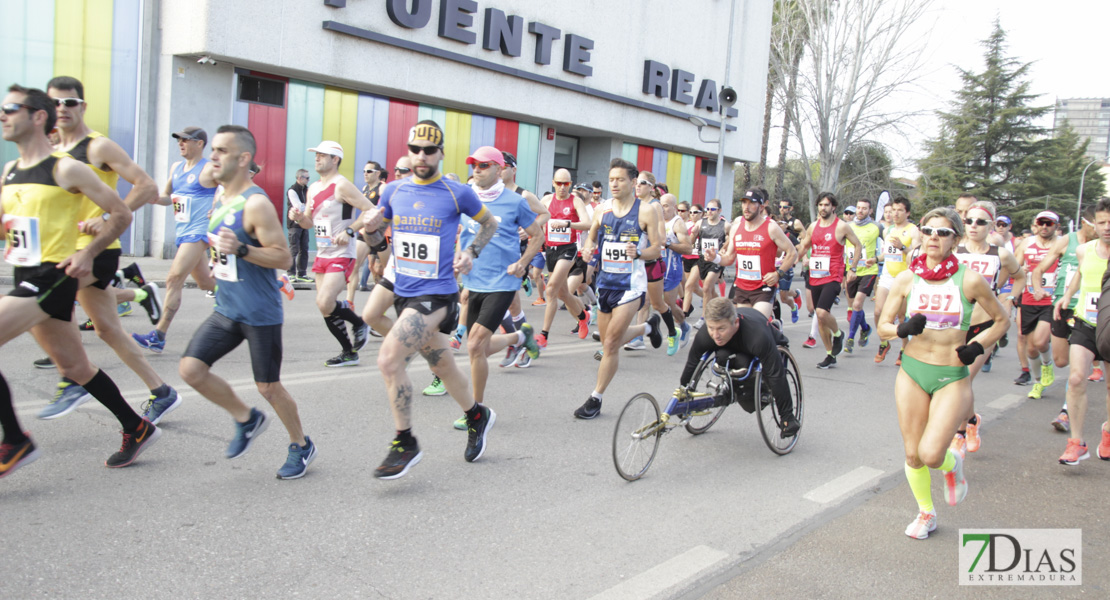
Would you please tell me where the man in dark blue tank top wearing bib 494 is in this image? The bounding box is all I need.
[574,159,663,419]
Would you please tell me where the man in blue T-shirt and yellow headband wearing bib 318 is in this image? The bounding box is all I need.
[363,121,497,479]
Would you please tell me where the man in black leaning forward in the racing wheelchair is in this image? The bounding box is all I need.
[679,298,800,438]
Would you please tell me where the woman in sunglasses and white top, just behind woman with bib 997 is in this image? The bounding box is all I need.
[952,201,1019,452]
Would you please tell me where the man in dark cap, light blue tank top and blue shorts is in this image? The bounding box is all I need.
[131,128,218,353]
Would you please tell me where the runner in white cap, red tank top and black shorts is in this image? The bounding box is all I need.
[1013,211,1060,398]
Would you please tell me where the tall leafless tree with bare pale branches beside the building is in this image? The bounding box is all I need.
[773,0,930,216]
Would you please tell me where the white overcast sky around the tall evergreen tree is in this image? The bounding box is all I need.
[794,0,1110,177]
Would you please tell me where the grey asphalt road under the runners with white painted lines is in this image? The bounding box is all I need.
[0,269,1110,598]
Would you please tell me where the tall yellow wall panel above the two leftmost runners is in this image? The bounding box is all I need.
[54,0,113,133]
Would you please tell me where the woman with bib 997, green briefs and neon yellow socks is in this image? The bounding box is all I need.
[878,209,1009,539]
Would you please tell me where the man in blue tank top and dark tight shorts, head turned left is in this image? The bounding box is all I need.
[180,125,316,479]
